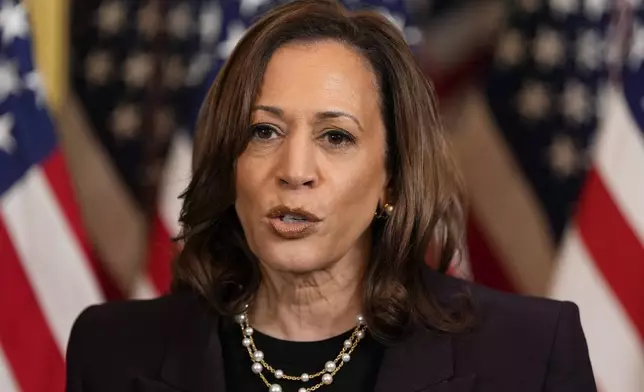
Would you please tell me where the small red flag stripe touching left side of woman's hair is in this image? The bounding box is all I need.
[147,213,176,293]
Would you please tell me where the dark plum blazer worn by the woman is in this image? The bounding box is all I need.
[67,269,596,392]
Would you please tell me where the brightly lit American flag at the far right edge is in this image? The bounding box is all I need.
[550,2,644,392]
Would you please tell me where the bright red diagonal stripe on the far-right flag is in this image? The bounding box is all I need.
[577,170,644,338]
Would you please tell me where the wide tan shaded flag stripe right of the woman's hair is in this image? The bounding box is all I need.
[451,89,554,295]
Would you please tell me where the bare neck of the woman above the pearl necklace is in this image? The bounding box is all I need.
[248,251,366,341]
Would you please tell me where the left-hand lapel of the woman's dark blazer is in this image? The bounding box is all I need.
[137,295,225,392]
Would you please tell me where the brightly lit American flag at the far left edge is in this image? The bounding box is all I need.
[0,1,103,392]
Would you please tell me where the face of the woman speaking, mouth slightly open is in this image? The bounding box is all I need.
[235,41,387,273]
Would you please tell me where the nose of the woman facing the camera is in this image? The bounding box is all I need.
[277,131,318,189]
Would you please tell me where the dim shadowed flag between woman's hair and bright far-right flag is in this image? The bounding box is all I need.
[456,0,610,294]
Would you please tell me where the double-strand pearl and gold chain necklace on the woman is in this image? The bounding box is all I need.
[235,311,367,392]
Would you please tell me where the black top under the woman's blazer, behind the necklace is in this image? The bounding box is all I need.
[219,319,383,392]
